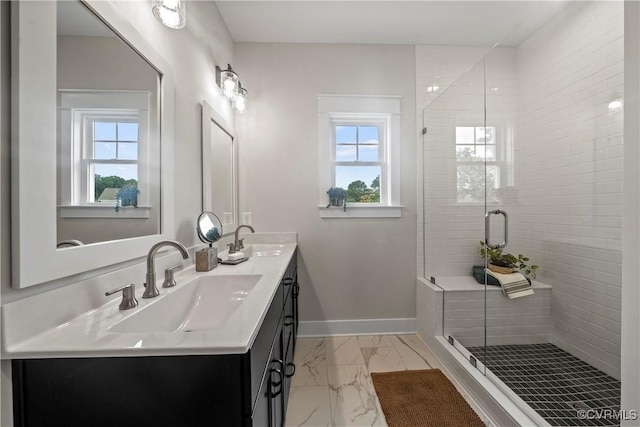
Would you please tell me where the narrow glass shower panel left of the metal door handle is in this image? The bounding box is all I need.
[422,52,488,369]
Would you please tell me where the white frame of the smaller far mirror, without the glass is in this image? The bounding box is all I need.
[202,101,240,236]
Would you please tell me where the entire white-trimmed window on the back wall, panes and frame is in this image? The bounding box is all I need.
[318,95,402,218]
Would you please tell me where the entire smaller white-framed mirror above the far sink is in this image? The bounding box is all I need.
[202,101,238,235]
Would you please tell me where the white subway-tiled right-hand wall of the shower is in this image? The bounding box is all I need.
[511,2,624,378]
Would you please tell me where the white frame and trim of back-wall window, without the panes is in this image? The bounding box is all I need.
[318,95,403,218]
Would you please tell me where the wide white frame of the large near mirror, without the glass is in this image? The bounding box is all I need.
[11,0,174,288]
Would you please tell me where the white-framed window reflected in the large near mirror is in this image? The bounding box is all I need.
[59,91,151,217]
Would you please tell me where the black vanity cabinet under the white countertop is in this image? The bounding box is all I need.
[13,253,299,427]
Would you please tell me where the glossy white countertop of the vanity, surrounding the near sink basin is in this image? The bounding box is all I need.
[3,243,297,359]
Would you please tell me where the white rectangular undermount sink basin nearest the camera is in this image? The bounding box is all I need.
[109,274,262,333]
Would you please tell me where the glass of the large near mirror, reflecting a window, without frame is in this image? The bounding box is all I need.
[57,1,161,244]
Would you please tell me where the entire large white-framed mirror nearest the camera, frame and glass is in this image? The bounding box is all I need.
[11,1,173,288]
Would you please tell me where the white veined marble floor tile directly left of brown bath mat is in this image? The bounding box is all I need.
[328,365,386,426]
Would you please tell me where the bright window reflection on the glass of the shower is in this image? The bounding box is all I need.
[455,126,512,203]
